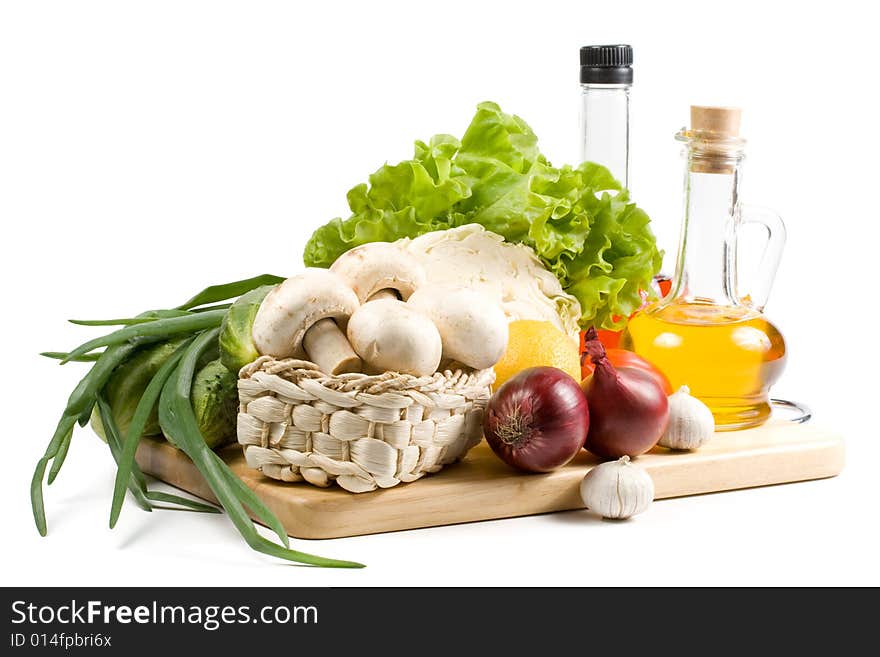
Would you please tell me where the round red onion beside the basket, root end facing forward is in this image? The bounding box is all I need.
[483,367,590,472]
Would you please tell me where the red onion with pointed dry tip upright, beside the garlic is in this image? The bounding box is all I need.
[581,329,669,459]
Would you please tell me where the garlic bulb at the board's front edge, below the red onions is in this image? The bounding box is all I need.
[581,456,654,519]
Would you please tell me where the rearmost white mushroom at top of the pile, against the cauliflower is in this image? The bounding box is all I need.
[330,242,425,303]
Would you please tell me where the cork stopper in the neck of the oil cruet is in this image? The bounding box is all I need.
[680,105,745,173]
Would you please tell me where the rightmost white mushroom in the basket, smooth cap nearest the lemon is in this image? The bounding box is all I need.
[407,285,508,370]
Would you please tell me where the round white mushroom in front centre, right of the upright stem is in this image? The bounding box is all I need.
[348,299,443,376]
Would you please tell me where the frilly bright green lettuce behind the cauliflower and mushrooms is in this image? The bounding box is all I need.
[303,102,662,328]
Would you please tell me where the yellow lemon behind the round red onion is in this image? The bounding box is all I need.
[495,319,581,390]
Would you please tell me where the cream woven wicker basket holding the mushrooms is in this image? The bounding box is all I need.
[238,356,495,493]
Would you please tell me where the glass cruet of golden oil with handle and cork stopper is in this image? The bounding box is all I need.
[621,106,785,431]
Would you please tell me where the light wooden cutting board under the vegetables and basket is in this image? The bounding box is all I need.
[137,420,844,538]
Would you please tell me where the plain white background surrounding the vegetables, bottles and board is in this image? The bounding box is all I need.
[0,0,880,586]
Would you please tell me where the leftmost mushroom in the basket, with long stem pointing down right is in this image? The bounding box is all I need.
[252,268,362,374]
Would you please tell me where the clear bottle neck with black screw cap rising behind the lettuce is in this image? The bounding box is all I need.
[581,45,633,188]
